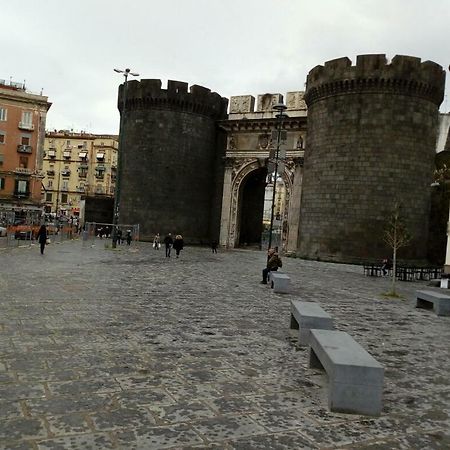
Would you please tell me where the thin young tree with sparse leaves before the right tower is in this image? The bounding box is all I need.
[384,202,411,297]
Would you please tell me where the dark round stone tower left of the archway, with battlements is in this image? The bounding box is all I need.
[118,80,228,243]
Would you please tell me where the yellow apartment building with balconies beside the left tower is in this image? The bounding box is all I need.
[42,130,118,218]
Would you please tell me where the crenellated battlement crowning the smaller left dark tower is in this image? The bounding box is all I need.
[117,79,228,119]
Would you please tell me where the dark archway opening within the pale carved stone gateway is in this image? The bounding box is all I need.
[239,167,267,248]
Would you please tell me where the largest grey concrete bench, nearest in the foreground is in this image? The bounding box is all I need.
[309,330,384,416]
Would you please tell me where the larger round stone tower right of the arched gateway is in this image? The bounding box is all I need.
[298,55,445,262]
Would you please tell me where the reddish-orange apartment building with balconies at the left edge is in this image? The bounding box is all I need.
[0,80,51,223]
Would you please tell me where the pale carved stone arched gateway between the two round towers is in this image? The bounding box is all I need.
[220,92,306,252]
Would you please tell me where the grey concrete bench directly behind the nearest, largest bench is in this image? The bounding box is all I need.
[291,300,334,346]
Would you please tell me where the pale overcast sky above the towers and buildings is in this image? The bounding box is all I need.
[0,0,450,133]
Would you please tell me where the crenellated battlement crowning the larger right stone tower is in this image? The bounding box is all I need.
[305,54,445,106]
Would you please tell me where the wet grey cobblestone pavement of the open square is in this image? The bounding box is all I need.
[0,240,450,450]
